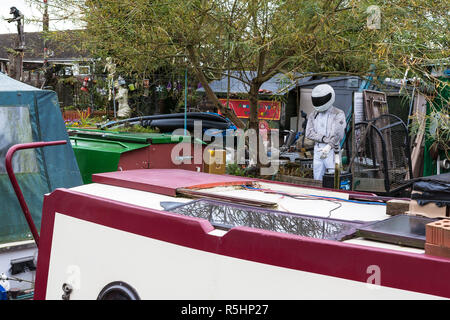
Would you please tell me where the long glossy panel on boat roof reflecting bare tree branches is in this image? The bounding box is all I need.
[169,199,364,241]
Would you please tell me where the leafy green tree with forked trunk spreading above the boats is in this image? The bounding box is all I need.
[28,0,449,140]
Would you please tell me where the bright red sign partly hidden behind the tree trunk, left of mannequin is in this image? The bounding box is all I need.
[219,99,281,120]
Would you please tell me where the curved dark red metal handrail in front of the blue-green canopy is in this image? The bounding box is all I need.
[5,140,67,247]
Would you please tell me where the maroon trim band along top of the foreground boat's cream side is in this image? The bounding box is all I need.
[35,189,450,299]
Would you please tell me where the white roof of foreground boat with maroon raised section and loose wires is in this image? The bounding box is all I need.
[67,169,424,254]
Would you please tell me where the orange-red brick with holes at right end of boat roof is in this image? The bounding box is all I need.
[425,219,450,258]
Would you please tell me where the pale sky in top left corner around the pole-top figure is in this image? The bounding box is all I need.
[0,0,73,34]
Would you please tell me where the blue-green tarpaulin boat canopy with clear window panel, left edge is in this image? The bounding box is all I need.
[0,72,82,243]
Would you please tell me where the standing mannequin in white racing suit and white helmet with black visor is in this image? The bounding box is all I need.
[306,84,347,180]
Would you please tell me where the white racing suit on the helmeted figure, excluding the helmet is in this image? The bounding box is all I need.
[306,106,347,180]
